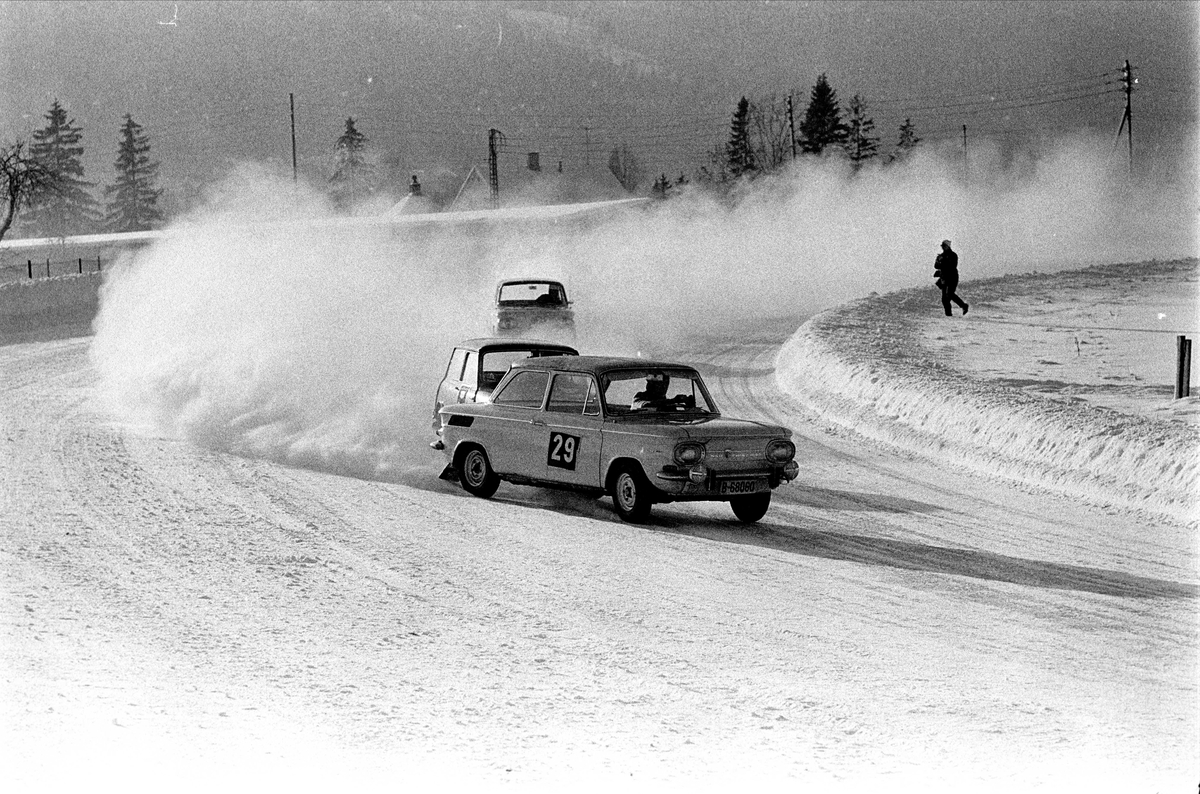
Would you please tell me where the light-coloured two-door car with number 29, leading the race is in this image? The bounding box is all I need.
[439,356,799,522]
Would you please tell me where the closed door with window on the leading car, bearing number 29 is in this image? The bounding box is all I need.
[541,372,602,487]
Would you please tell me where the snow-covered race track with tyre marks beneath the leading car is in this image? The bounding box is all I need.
[0,307,1198,792]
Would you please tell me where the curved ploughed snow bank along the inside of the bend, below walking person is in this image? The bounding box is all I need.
[776,257,1200,521]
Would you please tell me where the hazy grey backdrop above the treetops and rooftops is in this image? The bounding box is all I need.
[0,1,1200,204]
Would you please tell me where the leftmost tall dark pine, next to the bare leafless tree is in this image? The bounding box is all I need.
[22,100,100,237]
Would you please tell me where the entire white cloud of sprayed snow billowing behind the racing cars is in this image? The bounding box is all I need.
[92,133,1196,481]
